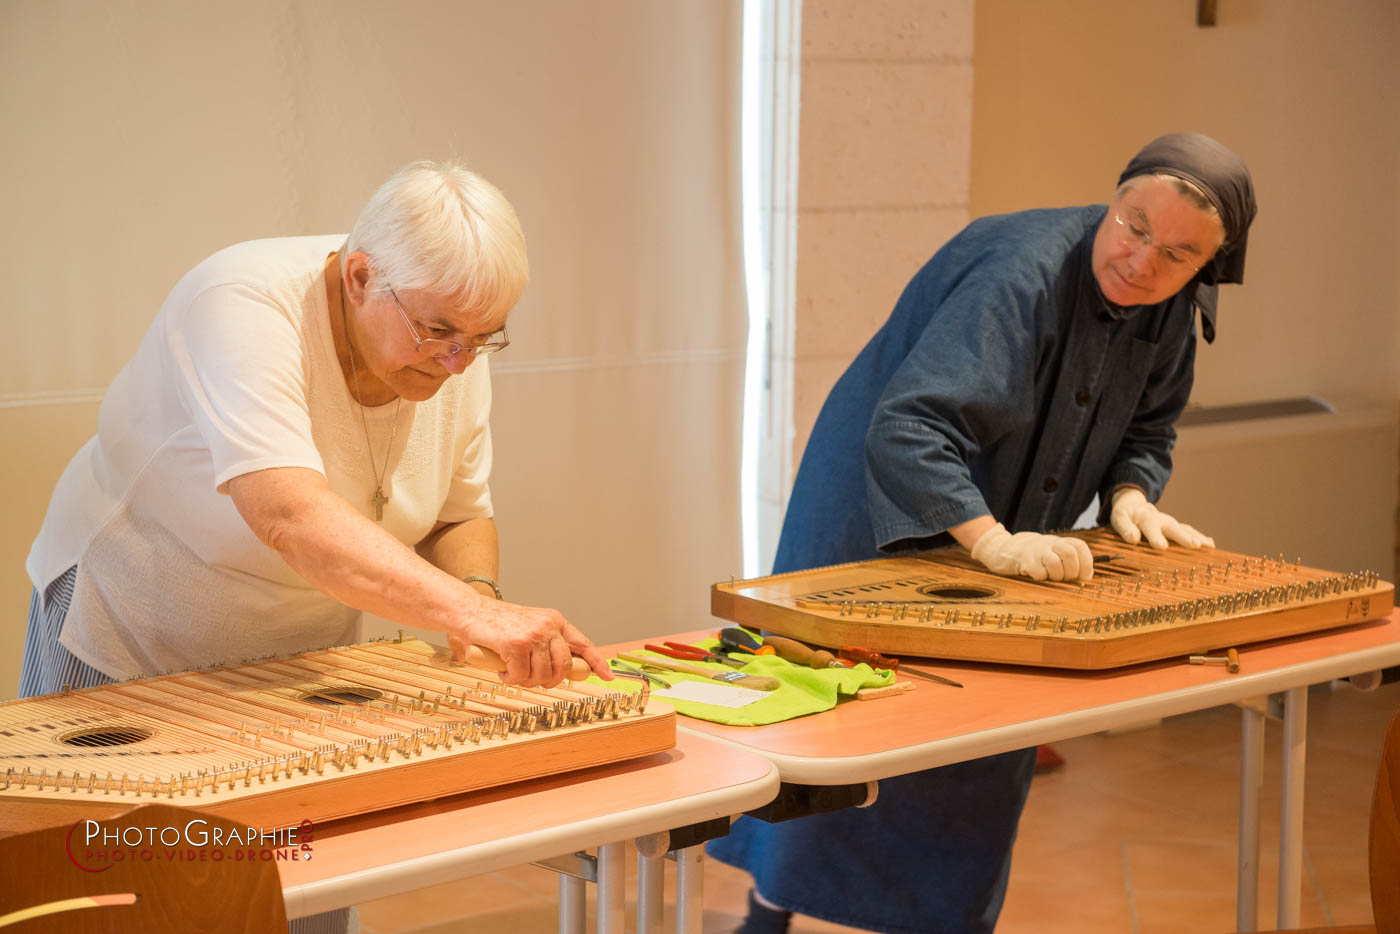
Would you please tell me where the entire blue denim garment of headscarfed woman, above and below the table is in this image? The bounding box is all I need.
[710,204,1196,934]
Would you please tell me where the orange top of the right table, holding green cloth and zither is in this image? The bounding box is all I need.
[621,611,1400,784]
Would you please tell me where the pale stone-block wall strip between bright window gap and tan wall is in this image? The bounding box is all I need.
[792,0,973,463]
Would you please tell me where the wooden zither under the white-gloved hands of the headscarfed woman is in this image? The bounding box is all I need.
[710,529,1394,669]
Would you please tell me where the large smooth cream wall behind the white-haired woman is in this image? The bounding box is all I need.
[0,0,745,696]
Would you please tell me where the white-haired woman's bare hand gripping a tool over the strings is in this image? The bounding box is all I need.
[448,598,612,688]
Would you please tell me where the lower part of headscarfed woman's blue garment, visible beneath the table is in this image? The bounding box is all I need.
[707,749,1036,934]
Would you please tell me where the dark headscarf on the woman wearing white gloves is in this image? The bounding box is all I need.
[1119,133,1257,342]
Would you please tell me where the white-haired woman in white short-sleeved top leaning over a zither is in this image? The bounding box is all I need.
[21,162,608,716]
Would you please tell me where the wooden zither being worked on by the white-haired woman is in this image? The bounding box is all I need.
[0,640,676,835]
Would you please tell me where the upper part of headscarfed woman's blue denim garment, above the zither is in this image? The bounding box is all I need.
[774,204,1196,570]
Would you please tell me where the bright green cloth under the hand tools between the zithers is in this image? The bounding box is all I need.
[589,639,895,727]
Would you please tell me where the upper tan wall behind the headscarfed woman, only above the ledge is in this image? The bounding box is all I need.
[972,0,1400,403]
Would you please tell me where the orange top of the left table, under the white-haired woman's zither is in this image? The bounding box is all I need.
[279,734,778,917]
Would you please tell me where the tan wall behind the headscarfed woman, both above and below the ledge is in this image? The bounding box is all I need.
[972,0,1400,574]
